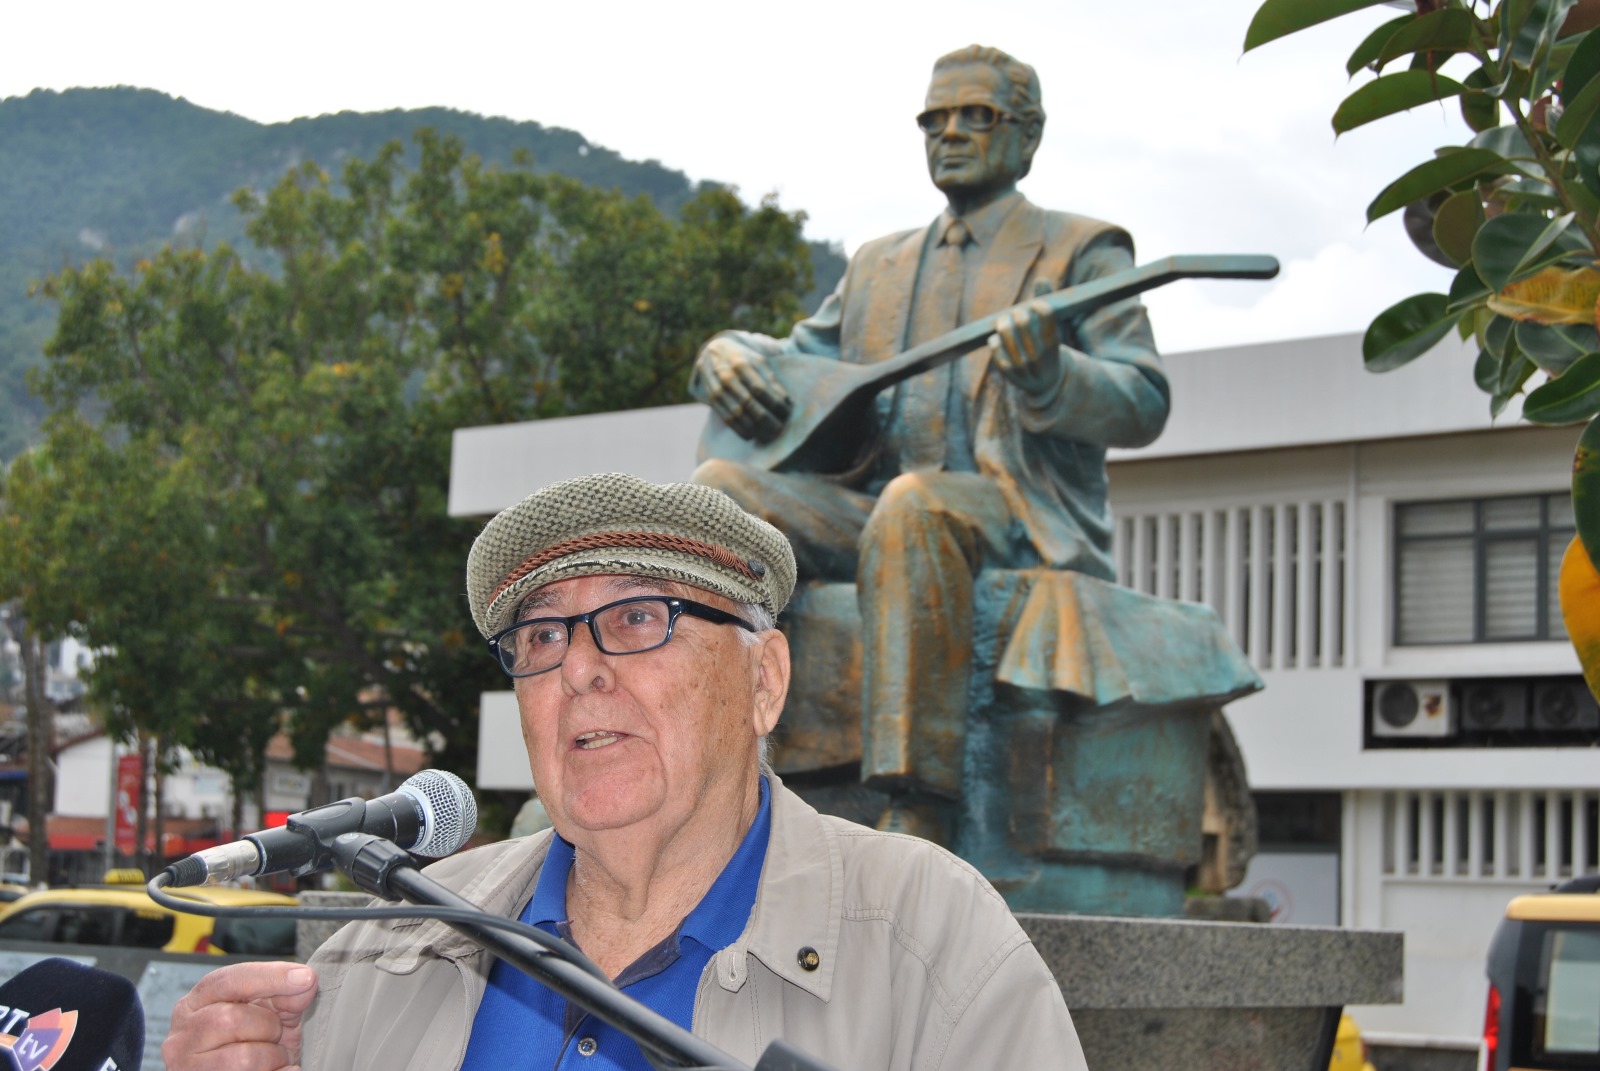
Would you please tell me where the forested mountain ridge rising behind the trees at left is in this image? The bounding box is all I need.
[0,86,845,463]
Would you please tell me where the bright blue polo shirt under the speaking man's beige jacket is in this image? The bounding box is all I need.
[461,778,771,1071]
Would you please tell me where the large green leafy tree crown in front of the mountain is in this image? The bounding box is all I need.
[0,131,810,800]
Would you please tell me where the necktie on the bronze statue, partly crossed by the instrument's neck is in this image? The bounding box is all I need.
[899,219,973,472]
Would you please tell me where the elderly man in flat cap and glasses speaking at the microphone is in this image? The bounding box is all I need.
[163,475,1083,1071]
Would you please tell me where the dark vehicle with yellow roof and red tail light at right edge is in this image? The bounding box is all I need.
[1480,877,1600,1071]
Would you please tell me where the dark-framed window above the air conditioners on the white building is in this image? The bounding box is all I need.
[1394,491,1576,644]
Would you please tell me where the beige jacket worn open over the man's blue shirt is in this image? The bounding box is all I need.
[302,778,1085,1071]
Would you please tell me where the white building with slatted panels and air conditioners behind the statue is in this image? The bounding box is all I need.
[450,335,1600,1049]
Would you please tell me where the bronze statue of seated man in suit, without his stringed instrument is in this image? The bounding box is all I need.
[691,45,1168,844]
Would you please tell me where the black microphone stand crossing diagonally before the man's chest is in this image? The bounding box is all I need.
[328,832,834,1071]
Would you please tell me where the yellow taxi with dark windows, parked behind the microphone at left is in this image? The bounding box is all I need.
[0,871,296,956]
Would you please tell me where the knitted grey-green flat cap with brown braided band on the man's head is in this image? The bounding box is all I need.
[467,472,795,639]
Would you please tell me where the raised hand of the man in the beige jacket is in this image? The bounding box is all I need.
[162,962,317,1071]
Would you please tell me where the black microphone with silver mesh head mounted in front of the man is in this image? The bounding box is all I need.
[166,770,478,887]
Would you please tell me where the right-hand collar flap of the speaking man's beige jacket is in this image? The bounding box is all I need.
[715,773,845,1001]
